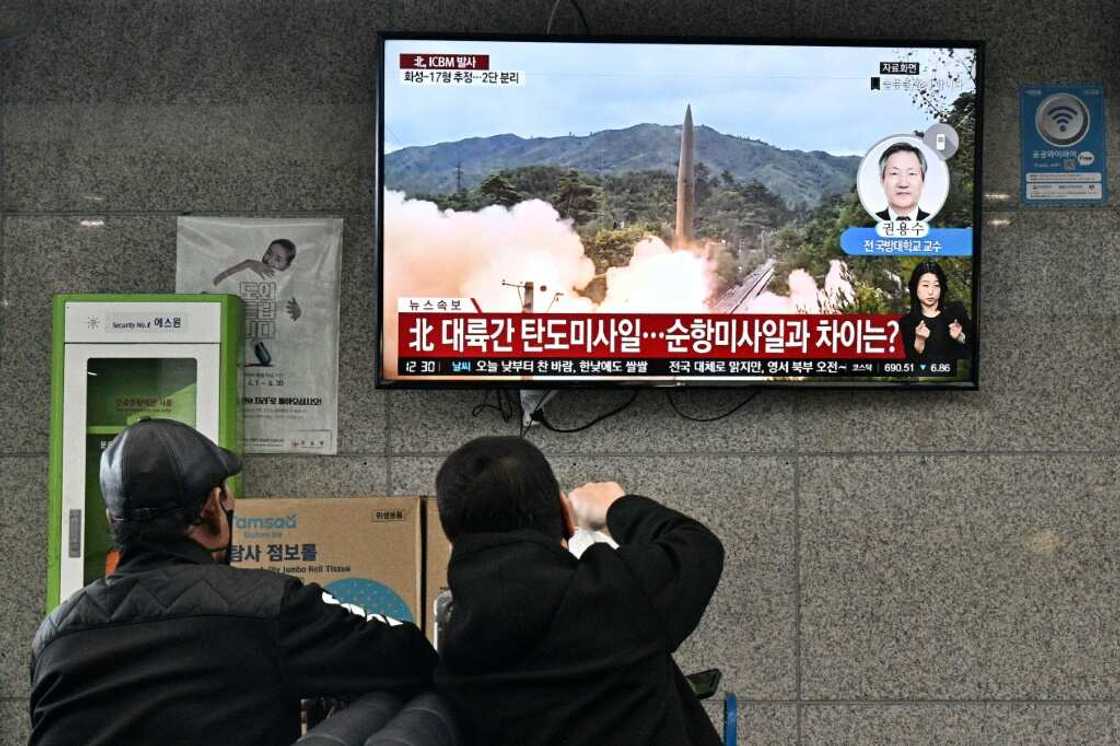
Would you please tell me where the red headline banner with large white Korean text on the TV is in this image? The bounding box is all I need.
[398,313,906,361]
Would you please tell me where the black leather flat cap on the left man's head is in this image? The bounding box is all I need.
[101,419,241,521]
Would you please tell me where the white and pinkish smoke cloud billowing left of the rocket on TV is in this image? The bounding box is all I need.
[382,190,715,376]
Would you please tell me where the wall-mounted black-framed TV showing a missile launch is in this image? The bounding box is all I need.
[376,35,982,388]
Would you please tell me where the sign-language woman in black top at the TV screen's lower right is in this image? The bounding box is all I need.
[900,262,972,363]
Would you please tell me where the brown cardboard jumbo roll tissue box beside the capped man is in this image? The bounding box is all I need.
[231,497,423,626]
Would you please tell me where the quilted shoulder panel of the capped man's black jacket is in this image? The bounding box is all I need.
[31,565,299,655]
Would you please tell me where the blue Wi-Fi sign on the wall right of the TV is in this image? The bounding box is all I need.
[1019,85,1109,207]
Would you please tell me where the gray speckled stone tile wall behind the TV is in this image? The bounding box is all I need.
[0,0,1120,745]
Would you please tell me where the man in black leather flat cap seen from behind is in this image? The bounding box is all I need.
[30,420,436,746]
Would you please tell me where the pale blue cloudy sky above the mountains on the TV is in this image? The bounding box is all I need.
[384,40,971,155]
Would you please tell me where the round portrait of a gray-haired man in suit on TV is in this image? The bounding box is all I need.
[856,134,949,222]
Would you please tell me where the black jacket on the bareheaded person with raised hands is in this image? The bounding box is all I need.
[436,495,724,746]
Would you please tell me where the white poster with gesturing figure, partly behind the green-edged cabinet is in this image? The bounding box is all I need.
[175,217,343,455]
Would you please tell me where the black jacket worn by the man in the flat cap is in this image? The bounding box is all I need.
[30,539,436,746]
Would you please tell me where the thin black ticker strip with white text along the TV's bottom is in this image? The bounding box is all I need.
[396,357,956,379]
